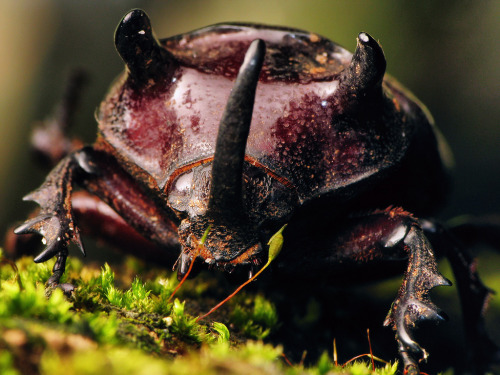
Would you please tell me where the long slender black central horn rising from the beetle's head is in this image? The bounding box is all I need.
[208,39,266,218]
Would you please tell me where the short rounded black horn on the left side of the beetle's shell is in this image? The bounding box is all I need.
[115,9,174,83]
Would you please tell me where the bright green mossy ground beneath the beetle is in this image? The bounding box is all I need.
[0,250,397,375]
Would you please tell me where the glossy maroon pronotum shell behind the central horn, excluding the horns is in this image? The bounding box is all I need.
[99,24,417,206]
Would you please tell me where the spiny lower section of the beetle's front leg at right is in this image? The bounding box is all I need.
[384,224,451,374]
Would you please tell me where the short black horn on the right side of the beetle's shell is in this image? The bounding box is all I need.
[340,32,386,97]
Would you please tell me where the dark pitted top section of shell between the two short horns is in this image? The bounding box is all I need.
[162,24,351,83]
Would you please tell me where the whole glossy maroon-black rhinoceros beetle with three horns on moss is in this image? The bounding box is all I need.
[15,10,498,373]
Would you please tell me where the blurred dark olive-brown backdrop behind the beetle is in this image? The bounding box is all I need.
[0,0,500,374]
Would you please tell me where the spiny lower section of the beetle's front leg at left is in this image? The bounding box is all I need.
[14,157,85,262]
